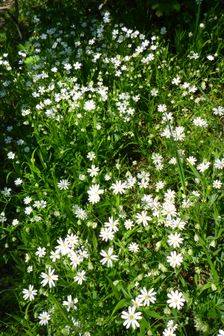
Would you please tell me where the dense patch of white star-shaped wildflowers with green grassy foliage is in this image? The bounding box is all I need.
[0,2,224,336]
